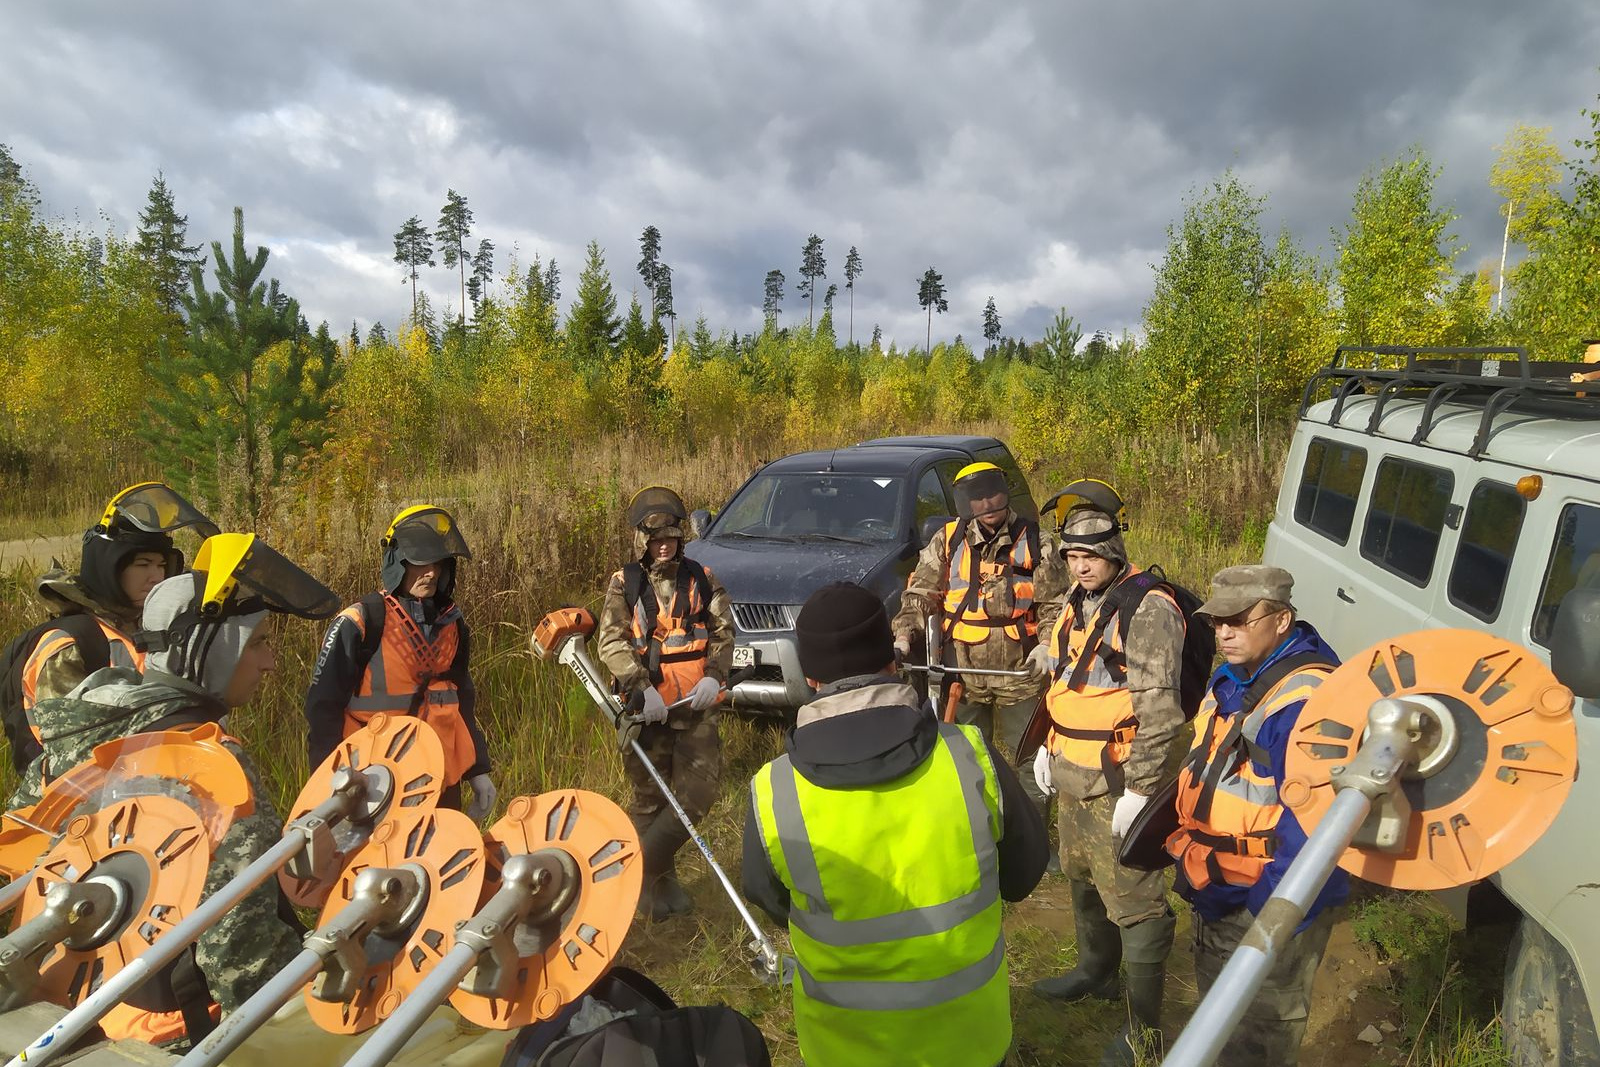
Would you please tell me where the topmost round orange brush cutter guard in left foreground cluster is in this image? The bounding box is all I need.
[278,712,445,907]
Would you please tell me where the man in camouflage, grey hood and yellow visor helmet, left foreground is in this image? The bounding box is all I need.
[11,533,339,1043]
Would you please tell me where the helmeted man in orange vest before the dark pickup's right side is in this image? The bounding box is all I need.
[894,462,1067,816]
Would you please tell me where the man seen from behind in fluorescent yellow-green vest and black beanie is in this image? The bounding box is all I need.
[742,582,1048,1067]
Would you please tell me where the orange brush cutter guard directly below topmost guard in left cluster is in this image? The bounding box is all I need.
[306,809,485,1033]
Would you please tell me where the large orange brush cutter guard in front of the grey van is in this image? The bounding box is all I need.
[1280,630,1578,889]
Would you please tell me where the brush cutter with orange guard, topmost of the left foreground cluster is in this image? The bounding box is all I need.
[0,715,443,1067]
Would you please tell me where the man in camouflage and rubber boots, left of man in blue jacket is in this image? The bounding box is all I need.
[1034,482,1184,1065]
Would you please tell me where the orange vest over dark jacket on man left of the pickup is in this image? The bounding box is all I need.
[339,593,478,785]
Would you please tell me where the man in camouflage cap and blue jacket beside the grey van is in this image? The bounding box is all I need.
[1166,566,1350,1067]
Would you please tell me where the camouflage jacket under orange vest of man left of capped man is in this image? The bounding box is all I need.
[1053,584,1184,800]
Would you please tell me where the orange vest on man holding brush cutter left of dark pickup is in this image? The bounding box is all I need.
[622,558,722,704]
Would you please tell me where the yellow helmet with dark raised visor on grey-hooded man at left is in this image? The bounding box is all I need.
[194,533,339,619]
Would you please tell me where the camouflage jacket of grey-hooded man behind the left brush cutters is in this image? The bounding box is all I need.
[11,667,302,1011]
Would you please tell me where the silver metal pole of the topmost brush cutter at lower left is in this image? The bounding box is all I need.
[6,827,307,1067]
